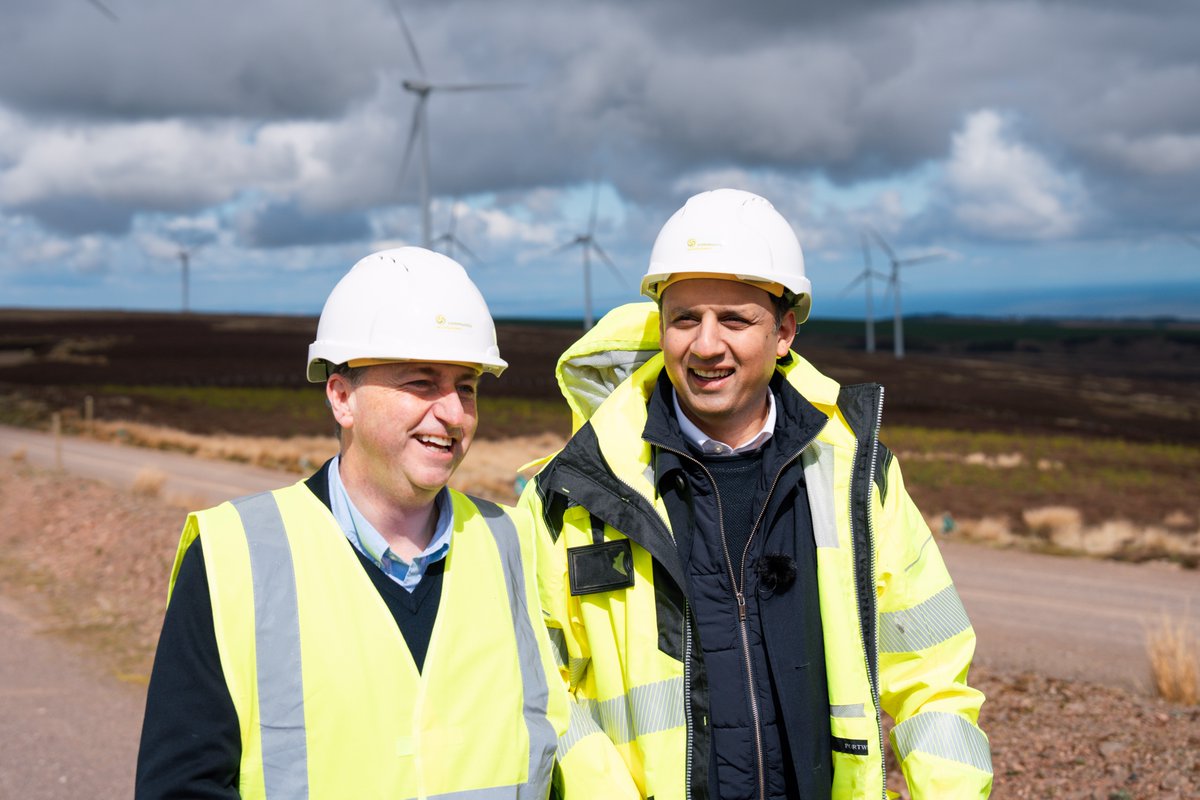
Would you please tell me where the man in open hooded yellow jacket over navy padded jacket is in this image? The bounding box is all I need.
[522,190,991,800]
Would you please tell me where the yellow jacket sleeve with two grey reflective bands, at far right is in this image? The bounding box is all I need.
[875,458,992,800]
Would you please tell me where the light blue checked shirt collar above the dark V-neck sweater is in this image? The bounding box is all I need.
[329,456,454,594]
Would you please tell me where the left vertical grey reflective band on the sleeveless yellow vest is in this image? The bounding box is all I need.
[233,492,308,798]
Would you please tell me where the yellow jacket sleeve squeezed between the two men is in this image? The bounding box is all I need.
[520,479,642,800]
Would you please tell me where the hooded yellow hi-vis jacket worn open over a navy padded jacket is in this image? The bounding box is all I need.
[521,303,992,800]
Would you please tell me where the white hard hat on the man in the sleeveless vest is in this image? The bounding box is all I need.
[308,247,509,383]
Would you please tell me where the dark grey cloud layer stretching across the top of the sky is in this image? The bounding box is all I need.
[0,0,1200,241]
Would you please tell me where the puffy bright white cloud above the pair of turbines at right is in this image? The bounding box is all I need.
[946,109,1086,240]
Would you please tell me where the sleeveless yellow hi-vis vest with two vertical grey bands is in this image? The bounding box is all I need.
[172,482,568,800]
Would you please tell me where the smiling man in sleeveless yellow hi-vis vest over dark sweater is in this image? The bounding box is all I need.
[137,247,568,800]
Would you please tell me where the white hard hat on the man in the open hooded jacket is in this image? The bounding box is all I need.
[642,188,812,323]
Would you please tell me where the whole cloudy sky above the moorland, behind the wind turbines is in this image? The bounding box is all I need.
[0,0,1200,318]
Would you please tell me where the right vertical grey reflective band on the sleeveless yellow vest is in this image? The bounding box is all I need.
[472,498,558,800]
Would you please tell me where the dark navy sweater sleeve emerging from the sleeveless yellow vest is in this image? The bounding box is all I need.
[134,540,241,800]
